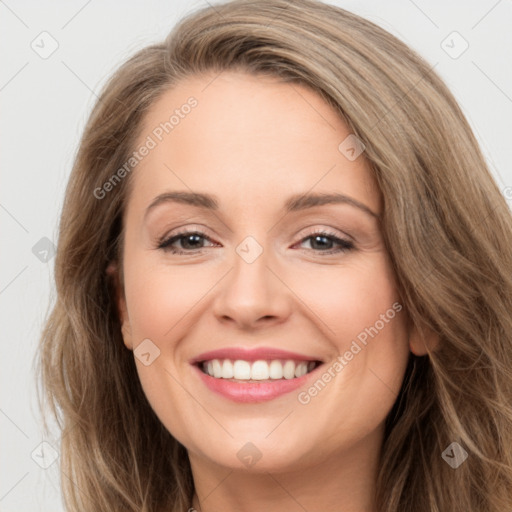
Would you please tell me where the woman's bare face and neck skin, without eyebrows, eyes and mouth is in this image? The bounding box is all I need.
[110,72,436,512]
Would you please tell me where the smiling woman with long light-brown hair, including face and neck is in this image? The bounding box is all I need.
[41,0,512,512]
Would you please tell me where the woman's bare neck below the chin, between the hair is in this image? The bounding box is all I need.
[189,428,383,512]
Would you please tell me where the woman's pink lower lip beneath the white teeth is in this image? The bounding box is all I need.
[194,365,319,403]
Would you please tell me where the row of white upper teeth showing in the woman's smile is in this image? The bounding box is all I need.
[202,359,316,380]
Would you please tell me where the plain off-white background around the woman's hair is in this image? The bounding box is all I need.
[0,0,512,512]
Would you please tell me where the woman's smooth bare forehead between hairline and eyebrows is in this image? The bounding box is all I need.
[124,71,380,216]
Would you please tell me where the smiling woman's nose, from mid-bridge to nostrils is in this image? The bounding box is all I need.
[213,242,293,330]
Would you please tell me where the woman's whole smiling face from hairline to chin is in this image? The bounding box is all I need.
[113,72,409,471]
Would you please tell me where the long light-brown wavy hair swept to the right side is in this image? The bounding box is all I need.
[38,0,512,512]
